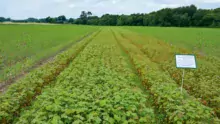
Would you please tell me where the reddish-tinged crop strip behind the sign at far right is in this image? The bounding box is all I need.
[118,29,220,117]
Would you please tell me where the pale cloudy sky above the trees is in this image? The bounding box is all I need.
[0,0,220,19]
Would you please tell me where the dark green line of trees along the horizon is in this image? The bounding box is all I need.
[0,5,220,27]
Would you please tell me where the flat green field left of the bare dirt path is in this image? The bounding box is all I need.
[0,24,97,82]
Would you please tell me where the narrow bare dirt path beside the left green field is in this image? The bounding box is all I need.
[0,32,94,94]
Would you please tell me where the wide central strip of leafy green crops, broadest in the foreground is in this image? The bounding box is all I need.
[16,30,155,124]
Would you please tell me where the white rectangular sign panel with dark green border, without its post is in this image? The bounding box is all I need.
[176,55,196,68]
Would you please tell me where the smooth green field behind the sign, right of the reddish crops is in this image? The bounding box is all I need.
[125,27,220,57]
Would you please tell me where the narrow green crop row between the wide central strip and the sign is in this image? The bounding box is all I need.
[111,29,218,123]
